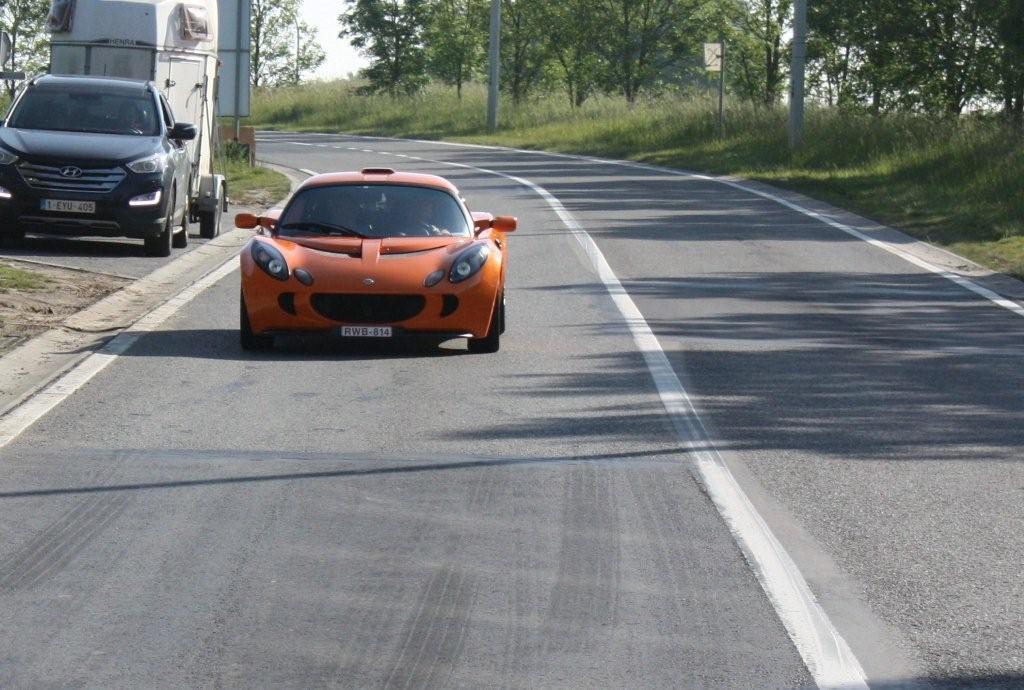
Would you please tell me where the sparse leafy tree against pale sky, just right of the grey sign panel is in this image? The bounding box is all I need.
[250,0,325,87]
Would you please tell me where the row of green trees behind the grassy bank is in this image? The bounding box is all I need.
[339,0,1024,120]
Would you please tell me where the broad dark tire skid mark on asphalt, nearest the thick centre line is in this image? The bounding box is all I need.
[542,466,621,655]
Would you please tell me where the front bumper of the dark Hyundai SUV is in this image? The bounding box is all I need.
[0,166,171,239]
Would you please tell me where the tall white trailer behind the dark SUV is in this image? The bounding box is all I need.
[49,0,227,238]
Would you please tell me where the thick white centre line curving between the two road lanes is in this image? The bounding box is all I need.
[292,143,868,690]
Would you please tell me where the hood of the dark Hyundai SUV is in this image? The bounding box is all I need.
[0,127,160,164]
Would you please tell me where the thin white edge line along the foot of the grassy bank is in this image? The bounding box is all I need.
[323,132,1024,316]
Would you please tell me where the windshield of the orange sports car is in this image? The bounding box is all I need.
[278,184,472,239]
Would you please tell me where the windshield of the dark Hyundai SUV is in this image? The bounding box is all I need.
[10,88,160,136]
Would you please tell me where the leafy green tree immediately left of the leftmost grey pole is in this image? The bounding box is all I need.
[424,0,488,99]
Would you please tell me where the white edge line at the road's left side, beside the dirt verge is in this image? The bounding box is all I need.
[0,257,238,448]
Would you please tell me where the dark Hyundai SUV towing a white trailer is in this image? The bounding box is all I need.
[0,76,196,256]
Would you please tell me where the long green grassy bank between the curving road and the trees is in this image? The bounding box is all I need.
[250,82,1024,276]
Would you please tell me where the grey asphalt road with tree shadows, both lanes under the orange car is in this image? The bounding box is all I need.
[0,135,1024,688]
